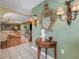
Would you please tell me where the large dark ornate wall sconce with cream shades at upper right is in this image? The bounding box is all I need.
[57,0,79,25]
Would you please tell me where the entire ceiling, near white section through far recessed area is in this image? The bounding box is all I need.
[0,0,44,23]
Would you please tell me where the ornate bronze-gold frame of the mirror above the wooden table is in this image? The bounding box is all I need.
[40,3,56,31]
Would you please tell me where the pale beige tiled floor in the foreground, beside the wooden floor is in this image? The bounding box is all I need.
[0,43,46,59]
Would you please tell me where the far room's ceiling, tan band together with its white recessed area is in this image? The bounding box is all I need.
[0,7,29,23]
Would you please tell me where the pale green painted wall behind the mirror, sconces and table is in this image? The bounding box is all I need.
[32,0,79,59]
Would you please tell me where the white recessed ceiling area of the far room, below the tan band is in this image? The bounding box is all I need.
[2,12,29,23]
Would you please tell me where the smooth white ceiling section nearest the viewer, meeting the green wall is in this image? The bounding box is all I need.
[0,0,44,15]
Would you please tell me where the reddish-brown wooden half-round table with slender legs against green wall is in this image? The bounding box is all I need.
[36,38,57,59]
